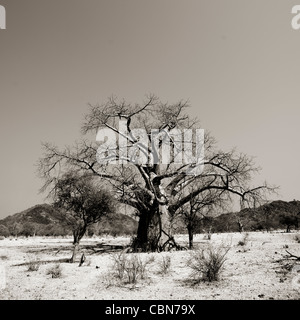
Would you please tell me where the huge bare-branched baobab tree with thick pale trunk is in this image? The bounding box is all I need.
[39,95,272,251]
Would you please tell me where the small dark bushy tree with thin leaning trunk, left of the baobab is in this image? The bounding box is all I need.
[51,172,116,262]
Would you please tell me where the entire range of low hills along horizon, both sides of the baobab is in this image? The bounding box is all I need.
[0,200,300,236]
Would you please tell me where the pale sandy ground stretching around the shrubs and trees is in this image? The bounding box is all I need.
[0,232,300,300]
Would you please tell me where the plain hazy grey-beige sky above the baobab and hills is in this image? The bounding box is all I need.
[0,0,300,218]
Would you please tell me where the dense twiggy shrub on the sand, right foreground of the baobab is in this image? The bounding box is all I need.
[187,246,229,283]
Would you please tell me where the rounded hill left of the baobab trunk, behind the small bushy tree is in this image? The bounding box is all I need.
[0,204,137,236]
